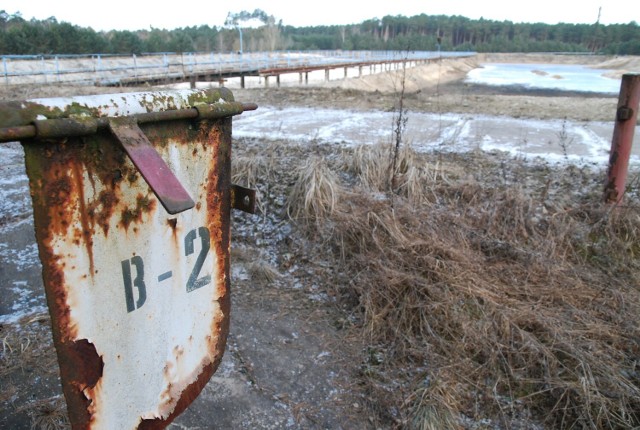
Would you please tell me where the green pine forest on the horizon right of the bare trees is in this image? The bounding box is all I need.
[284,14,640,55]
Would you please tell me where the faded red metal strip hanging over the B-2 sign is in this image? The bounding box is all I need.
[109,117,195,215]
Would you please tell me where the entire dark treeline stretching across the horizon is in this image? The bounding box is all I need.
[0,11,640,55]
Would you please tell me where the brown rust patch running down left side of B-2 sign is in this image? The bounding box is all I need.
[23,137,155,428]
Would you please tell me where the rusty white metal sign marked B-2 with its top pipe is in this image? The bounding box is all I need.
[0,89,256,429]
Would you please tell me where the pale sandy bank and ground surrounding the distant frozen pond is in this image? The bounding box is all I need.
[234,54,640,121]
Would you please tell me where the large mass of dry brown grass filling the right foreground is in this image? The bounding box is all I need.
[290,147,640,429]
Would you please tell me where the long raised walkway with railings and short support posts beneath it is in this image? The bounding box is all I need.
[0,51,475,87]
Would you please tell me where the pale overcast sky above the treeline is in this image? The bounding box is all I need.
[0,0,640,31]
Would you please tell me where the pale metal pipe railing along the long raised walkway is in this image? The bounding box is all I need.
[2,51,473,85]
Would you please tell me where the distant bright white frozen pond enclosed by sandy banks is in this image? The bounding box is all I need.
[466,63,620,94]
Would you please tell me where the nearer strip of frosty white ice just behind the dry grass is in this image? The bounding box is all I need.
[233,106,640,167]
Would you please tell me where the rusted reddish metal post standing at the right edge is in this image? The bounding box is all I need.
[604,73,640,204]
